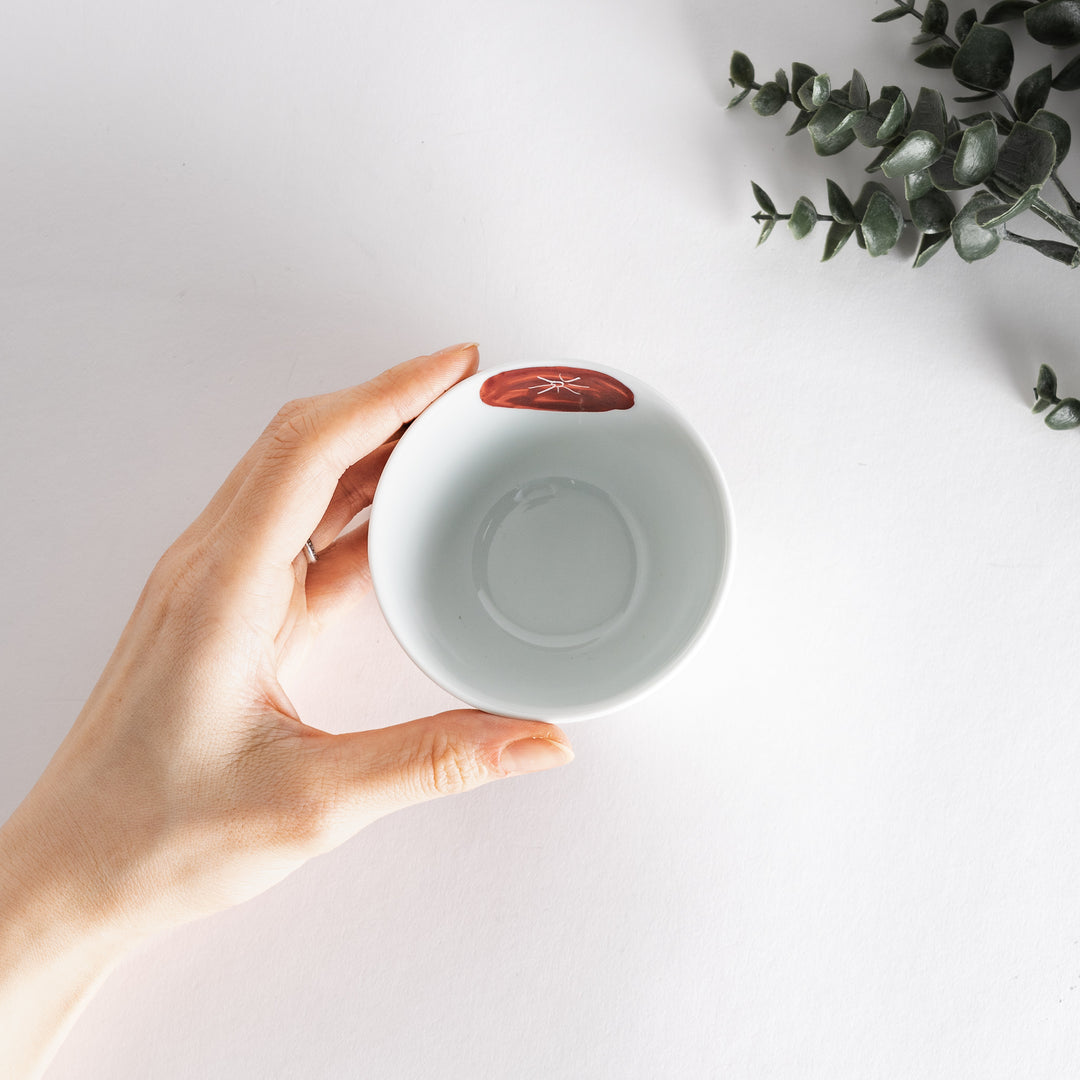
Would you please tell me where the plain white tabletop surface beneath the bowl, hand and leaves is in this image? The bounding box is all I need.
[6,0,1080,1080]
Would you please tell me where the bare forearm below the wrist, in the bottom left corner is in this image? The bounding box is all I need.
[0,794,141,1080]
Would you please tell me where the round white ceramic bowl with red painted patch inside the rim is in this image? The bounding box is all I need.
[368,362,733,723]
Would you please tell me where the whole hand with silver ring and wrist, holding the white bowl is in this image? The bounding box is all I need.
[0,346,572,1076]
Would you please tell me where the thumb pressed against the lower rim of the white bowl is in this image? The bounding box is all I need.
[332,708,573,820]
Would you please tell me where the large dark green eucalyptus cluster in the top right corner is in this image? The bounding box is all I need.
[729,0,1080,268]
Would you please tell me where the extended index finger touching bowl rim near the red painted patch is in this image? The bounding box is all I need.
[218,343,480,566]
